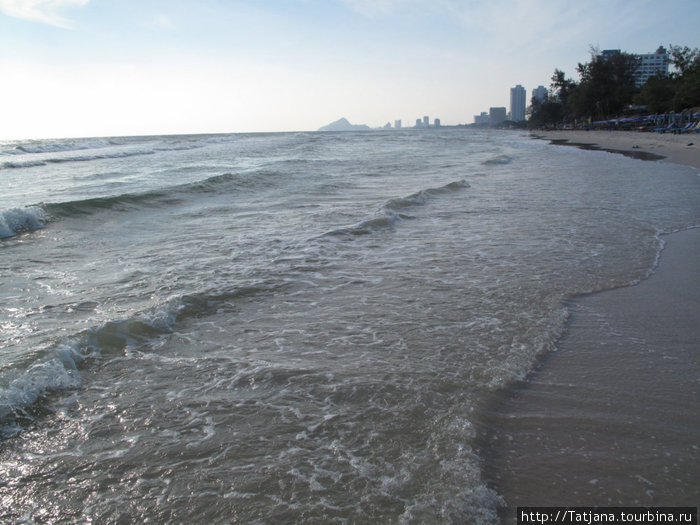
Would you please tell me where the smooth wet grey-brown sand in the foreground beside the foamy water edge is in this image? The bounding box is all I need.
[482,229,700,523]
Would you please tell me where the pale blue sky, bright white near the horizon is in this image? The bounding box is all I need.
[0,0,700,140]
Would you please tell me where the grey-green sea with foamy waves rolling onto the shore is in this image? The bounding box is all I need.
[0,128,700,524]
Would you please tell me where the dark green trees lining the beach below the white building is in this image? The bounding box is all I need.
[528,45,700,128]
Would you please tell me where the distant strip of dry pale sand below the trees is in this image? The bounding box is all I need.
[533,130,700,169]
